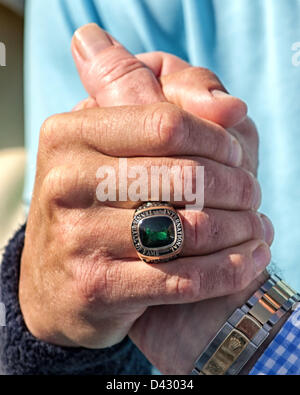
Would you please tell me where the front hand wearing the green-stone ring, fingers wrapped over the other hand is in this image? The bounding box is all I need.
[20,23,273,362]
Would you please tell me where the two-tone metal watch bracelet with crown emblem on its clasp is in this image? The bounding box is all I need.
[191,275,300,375]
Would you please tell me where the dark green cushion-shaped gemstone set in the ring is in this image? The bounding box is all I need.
[139,216,175,248]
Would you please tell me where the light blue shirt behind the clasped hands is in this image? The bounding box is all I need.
[25,0,300,289]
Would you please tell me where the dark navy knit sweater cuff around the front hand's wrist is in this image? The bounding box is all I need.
[0,225,151,375]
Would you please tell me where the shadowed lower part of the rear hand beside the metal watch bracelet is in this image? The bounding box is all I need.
[130,273,268,374]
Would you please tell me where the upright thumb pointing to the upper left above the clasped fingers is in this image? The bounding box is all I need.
[72,23,166,107]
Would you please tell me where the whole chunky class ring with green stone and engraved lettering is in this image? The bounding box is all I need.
[131,202,184,263]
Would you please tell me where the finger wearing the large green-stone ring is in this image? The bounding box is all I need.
[59,207,274,259]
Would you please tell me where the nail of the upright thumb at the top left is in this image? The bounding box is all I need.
[74,23,113,60]
